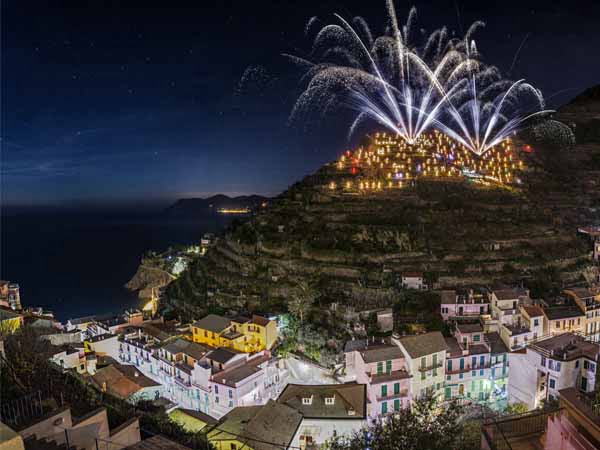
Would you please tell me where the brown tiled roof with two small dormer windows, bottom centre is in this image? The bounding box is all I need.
[277,383,367,419]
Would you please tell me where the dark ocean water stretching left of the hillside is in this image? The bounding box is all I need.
[0,211,231,320]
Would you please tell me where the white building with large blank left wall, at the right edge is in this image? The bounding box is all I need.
[508,333,600,409]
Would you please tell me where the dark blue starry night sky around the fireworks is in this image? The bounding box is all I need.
[1,0,600,205]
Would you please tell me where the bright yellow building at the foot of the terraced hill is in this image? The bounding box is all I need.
[192,314,277,353]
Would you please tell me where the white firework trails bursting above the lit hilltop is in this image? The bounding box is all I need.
[284,0,547,155]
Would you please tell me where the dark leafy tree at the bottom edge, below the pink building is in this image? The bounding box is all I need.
[327,397,465,450]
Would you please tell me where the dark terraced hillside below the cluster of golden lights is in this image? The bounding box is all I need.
[168,131,600,320]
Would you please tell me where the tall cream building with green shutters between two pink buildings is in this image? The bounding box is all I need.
[395,331,448,398]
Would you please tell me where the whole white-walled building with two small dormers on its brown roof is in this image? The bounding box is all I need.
[277,383,368,449]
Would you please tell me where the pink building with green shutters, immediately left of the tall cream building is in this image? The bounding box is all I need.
[344,340,411,419]
